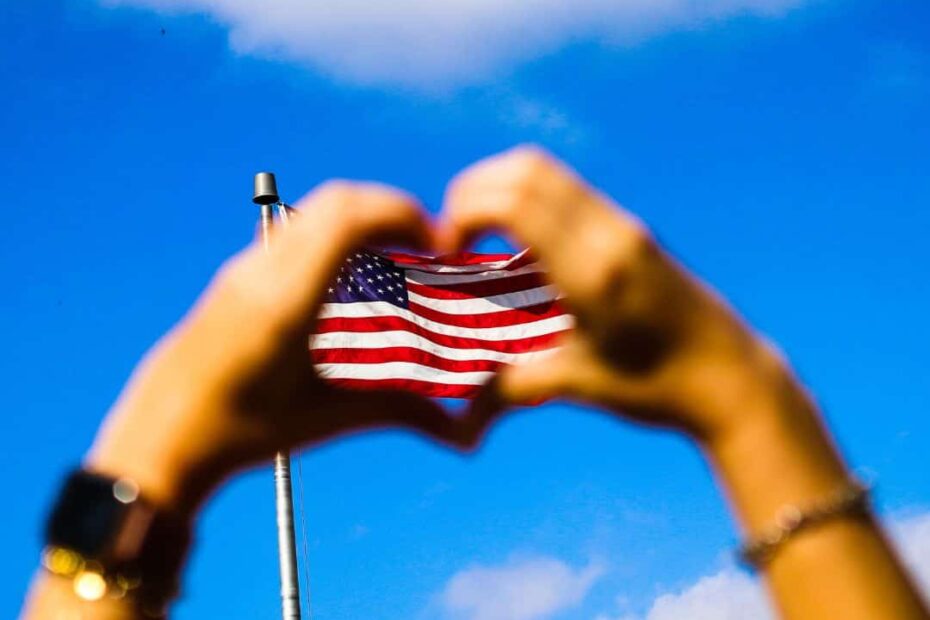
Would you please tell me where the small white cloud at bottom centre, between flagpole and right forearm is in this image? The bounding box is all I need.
[440,557,604,620]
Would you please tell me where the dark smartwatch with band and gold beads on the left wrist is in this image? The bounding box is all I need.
[42,469,190,618]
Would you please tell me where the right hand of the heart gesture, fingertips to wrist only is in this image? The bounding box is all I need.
[439,147,786,446]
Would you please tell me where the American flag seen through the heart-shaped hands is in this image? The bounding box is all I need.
[310,250,573,398]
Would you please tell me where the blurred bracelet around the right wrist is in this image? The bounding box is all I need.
[739,480,869,569]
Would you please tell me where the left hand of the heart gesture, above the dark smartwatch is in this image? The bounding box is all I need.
[88,183,462,510]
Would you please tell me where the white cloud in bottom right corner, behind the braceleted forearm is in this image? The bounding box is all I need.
[597,513,930,620]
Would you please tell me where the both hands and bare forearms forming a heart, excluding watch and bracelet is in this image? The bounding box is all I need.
[45,148,928,620]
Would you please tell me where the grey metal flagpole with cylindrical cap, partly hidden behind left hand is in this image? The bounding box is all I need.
[252,172,300,620]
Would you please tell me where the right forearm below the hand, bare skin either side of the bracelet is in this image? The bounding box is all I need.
[705,358,928,620]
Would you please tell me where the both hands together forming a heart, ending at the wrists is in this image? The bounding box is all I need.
[88,147,786,509]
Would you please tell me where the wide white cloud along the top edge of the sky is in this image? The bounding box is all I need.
[99,0,805,89]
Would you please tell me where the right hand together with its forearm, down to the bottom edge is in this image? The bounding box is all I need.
[439,148,927,620]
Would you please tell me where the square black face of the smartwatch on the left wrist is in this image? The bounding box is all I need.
[46,471,130,558]
